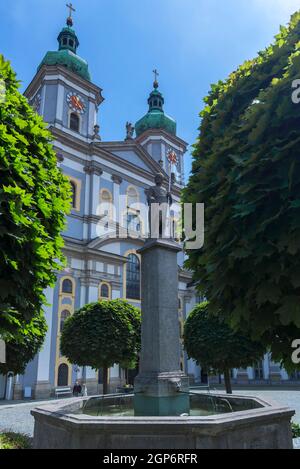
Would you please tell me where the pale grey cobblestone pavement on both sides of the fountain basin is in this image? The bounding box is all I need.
[0,389,300,437]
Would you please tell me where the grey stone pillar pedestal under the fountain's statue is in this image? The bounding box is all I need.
[134,239,189,416]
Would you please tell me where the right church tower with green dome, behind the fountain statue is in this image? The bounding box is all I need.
[135,70,187,186]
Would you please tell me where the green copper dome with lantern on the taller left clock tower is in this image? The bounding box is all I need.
[38,18,91,81]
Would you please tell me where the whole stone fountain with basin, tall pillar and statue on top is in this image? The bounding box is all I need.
[32,174,294,449]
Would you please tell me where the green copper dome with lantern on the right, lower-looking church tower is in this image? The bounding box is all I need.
[135,80,177,137]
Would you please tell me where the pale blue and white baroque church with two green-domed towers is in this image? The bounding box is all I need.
[0,12,300,399]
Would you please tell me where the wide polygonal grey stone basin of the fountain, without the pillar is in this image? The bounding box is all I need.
[32,394,295,450]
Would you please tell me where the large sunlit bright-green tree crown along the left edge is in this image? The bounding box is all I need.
[0,55,70,342]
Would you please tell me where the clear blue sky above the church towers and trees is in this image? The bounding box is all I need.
[0,0,300,176]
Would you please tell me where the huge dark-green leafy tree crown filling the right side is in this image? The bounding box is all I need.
[183,12,300,366]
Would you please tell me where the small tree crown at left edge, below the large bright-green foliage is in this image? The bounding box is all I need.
[0,314,47,375]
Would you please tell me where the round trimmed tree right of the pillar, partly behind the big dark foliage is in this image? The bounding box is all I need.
[184,302,265,394]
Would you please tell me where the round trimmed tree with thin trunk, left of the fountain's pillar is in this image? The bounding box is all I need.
[61,300,141,394]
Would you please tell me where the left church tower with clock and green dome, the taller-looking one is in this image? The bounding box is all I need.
[25,4,103,143]
